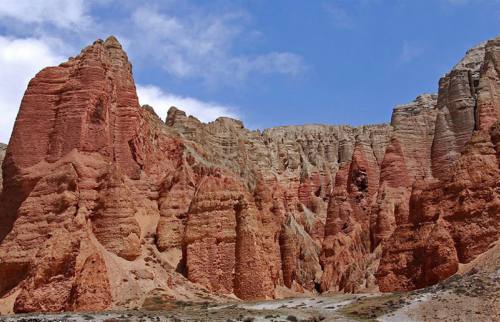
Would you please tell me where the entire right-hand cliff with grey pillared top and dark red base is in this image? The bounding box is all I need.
[377,38,500,291]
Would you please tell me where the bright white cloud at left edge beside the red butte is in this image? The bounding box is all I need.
[0,36,63,143]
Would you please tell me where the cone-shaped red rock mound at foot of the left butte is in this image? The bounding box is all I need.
[14,230,111,312]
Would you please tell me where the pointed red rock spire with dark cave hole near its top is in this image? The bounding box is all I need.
[321,138,386,292]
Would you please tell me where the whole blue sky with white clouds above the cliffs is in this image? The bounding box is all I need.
[0,0,500,141]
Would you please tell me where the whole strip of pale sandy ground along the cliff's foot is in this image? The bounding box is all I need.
[0,288,500,322]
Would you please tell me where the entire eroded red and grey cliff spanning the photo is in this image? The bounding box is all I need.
[0,37,500,312]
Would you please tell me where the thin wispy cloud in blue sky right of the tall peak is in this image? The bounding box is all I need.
[132,7,304,85]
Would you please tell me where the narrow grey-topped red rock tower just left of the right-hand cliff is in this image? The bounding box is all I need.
[370,95,436,250]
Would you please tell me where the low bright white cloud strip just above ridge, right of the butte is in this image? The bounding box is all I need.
[137,85,239,122]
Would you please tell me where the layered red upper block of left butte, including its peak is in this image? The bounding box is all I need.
[5,37,140,176]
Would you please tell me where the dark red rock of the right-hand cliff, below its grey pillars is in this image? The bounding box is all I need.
[378,38,500,291]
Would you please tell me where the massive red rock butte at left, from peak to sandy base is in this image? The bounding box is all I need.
[0,37,219,312]
